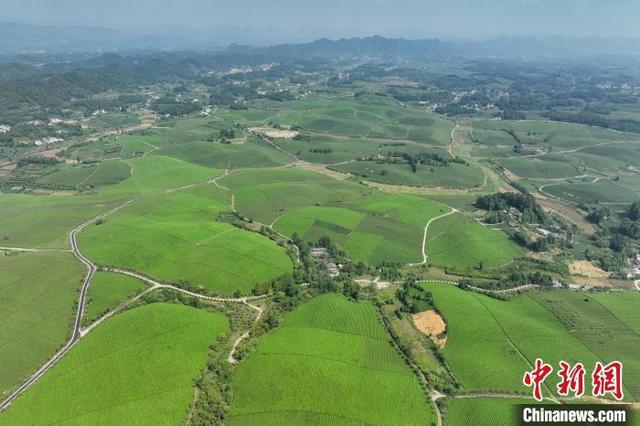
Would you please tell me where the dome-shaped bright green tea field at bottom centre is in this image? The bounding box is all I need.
[228,295,435,425]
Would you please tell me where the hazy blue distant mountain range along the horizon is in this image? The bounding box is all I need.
[0,23,640,59]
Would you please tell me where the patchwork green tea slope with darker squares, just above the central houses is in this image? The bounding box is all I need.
[221,169,456,265]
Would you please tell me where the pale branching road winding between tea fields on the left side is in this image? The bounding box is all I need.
[0,176,265,412]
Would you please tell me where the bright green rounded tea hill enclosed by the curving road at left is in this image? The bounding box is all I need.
[79,186,292,294]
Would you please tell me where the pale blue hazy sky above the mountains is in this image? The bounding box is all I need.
[0,0,640,39]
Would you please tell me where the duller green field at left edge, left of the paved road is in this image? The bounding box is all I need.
[0,253,84,395]
